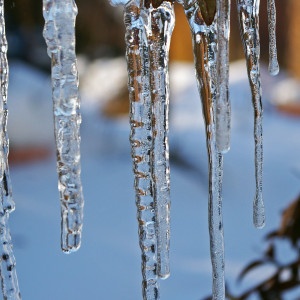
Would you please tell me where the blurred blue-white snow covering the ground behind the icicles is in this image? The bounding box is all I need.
[4,59,300,300]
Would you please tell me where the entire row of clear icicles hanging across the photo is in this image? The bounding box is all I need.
[0,0,279,300]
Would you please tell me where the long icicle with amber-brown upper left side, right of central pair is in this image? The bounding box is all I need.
[184,0,225,300]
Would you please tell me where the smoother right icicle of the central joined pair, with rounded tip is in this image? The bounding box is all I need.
[148,2,174,278]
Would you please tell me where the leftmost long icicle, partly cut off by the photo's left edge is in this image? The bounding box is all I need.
[0,0,21,300]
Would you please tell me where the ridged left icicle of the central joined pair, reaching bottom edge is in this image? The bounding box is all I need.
[125,0,159,300]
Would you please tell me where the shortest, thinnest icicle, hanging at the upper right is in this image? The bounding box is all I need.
[268,0,279,76]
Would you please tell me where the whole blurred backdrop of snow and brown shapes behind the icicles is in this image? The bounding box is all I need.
[4,0,300,300]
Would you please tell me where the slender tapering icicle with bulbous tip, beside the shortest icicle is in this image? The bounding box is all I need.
[237,0,265,228]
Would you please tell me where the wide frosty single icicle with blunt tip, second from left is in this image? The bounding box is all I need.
[43,0,83,253]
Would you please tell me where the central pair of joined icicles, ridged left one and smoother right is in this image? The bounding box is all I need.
[125,0,174,299]
